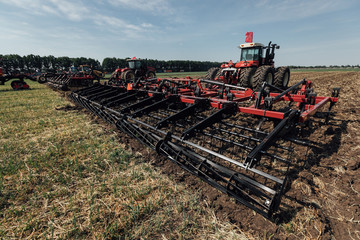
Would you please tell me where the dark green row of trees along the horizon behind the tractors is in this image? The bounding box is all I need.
[0,54,221,73]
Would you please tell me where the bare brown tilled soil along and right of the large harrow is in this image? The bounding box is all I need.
[84,71,360,239]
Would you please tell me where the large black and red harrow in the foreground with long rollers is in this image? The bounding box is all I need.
[70,79,339,217]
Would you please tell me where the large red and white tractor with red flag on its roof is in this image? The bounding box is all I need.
[205,33,290,91]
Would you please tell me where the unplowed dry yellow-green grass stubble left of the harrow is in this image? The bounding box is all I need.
[0,82,246,239]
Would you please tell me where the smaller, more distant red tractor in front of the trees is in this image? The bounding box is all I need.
[108,57,156,85]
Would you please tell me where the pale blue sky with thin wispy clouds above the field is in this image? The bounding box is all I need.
[0,0,360,66]
